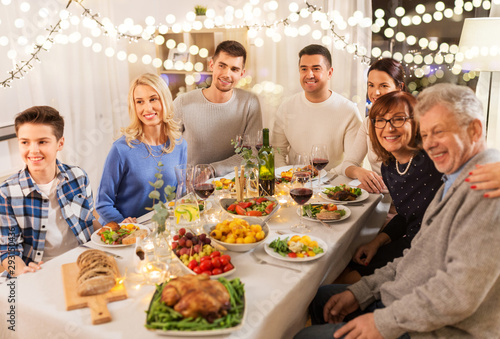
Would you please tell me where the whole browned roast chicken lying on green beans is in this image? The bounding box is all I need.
[161,274,231,322]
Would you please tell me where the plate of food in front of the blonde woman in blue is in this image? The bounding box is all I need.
[90,221,149,247]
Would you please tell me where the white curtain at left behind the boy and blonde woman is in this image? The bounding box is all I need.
[0,0,129,192]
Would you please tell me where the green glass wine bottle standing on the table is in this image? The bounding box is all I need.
[259,128,275,196]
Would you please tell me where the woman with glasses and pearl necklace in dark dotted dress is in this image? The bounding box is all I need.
[336,91,442,283]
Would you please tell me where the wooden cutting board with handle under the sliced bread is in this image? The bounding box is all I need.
[62,258,127,325]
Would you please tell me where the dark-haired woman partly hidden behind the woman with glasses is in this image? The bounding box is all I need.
[342,58,405,193]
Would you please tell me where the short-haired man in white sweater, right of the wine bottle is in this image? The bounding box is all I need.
[271,45,361,174]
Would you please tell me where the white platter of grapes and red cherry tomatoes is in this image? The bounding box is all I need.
[171,228,236,279]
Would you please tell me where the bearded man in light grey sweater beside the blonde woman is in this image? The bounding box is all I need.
[174,40,262,176]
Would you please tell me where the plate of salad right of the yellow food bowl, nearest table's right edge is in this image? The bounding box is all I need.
[264,234,328,262]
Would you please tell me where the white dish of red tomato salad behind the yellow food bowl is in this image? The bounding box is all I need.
[219,196,281,218]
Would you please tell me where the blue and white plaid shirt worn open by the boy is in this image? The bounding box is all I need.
[0,160,94,264]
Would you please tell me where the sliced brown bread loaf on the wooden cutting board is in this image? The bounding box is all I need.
[76,250,119,296]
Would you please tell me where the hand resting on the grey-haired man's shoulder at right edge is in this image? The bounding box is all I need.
[465,162,500,198]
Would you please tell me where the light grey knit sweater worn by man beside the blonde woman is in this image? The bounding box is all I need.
[174,88,262,176]
